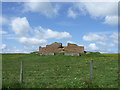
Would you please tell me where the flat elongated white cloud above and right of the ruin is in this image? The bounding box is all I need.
[83,33,106,41]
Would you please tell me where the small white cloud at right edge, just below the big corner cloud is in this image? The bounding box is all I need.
[104,16,118,26]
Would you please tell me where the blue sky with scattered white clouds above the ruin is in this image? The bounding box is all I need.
[0,2,119,53]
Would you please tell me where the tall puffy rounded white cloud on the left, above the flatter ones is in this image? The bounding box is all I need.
[10,17,31,36]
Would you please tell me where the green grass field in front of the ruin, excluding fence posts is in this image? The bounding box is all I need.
[2,53,118,88]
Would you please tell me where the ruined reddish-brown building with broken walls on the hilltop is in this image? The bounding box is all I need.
[39,42,84,53]
